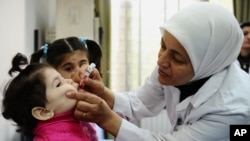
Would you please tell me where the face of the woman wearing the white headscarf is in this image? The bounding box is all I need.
[157,31,194,86]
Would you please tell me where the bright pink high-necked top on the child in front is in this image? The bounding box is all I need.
[33,111,98,141]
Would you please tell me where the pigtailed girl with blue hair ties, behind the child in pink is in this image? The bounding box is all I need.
[31,37,102,78]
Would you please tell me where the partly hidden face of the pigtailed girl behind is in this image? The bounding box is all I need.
[57,50,89,79]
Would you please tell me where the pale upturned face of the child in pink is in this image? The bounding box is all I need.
[44,68,78,114]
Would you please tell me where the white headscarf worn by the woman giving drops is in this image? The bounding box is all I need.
[161,2,244,81]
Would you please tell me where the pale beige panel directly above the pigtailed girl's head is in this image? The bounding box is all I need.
[55,0,94,39]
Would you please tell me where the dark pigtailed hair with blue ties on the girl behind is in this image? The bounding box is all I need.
[30,37,102,72]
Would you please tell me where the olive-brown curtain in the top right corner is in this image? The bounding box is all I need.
[233,0,250,23]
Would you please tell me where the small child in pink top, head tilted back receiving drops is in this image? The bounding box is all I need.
[2,53,96,141]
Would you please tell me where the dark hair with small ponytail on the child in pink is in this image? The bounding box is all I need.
[2,53,51,137]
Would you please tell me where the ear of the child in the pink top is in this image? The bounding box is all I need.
[32,107,54,120]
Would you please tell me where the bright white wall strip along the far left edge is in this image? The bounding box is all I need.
[0,0,25,141]
